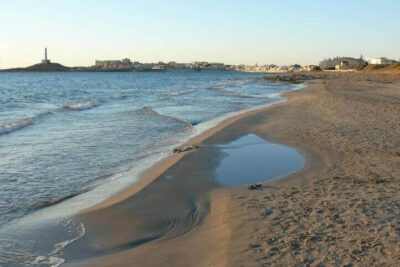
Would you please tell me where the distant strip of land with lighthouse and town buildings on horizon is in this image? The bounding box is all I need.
[0,48,398,73]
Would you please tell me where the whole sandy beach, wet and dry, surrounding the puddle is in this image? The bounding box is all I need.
[65,73,400,266]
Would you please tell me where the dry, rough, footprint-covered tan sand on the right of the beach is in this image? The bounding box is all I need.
[229,74,400,266]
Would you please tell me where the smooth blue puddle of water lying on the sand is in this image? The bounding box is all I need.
[216,134,304,186]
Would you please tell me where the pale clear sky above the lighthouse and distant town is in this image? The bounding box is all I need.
[0,0,400,68]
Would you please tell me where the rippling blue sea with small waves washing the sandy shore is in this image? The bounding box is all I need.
[0,72,299,266]
